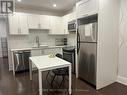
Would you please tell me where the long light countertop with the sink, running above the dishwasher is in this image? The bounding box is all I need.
[11,45,75,52]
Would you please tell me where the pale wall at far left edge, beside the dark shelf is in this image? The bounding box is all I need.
[0,17,6,57]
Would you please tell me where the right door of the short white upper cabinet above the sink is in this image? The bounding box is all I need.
[40,15,50,29]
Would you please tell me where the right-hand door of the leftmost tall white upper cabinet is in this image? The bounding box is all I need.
[19,13,29,35]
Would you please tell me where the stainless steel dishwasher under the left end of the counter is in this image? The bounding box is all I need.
[14,51,31,72]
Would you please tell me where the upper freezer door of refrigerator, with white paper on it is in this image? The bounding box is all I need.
[78,22,98,42]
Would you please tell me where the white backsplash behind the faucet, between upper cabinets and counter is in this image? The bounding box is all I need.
[8,29,64,49]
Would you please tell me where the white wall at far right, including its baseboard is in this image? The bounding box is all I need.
[118,0,127,85]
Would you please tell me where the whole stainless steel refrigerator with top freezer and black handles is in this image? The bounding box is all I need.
[77,15,98,86]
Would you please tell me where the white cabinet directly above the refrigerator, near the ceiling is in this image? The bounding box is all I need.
[76,0,99,18]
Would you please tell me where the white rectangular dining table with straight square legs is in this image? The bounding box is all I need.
[29,55,72,95]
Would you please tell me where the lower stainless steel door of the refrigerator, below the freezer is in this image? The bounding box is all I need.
[78,43,97,85]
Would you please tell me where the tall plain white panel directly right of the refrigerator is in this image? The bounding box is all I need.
[97,0,119,89]
